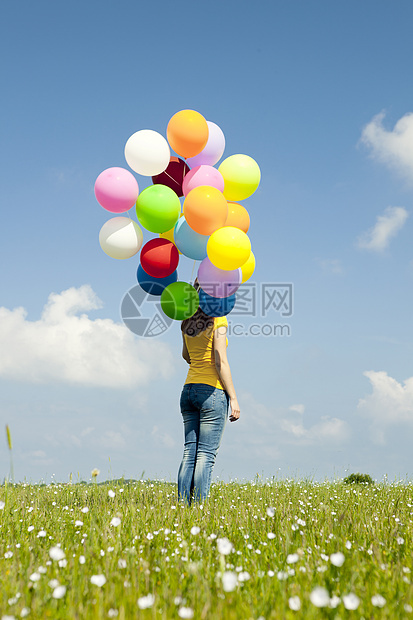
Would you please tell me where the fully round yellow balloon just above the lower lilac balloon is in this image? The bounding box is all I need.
[207,226,251,271]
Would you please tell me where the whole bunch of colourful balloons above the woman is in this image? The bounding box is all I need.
[95,110,261,320]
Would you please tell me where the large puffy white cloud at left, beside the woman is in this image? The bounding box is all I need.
[0,285,174,388]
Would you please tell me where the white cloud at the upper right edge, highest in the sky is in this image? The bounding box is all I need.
[361,112,413,182]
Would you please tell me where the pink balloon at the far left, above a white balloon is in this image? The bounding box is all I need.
[95,168,139,213]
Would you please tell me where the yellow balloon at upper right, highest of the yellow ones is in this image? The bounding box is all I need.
[218,155,261,201]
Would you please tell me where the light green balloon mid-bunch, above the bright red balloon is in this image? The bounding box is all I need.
[136,184,181,233]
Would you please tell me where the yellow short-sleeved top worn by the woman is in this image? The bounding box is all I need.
[184,316,228,390]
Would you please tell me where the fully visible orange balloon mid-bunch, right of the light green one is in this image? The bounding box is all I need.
[184,185,228,236]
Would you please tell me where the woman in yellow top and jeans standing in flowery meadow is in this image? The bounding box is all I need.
[178,298,240,504]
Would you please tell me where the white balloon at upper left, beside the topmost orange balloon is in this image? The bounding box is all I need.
[125,129,171,177]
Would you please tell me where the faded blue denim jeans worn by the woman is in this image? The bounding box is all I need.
[178,383,229,504]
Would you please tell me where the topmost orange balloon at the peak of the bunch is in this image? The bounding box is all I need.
[166,110,209,157]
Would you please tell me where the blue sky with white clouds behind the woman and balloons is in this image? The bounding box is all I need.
[0,0,413,481]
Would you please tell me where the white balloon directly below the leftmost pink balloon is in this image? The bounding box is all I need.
[99,217,143,258]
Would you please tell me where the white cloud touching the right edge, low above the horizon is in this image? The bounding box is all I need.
[358,370,413,434]
